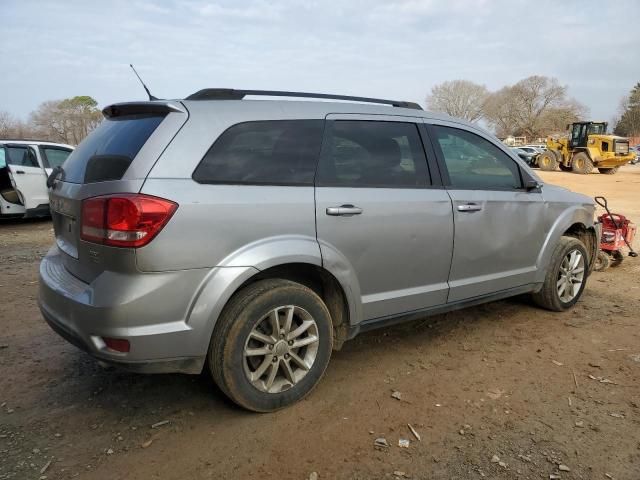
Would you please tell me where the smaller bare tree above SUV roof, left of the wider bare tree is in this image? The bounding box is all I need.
[427,80,489,122]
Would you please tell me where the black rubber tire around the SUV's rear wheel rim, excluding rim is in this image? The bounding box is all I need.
[208,279,333,412]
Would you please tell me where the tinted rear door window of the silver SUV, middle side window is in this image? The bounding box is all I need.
[318,120,428,188]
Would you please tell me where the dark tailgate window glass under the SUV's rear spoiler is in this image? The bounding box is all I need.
[63,115,164,183]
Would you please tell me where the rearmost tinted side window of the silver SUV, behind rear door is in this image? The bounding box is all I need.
[193,120,324,185]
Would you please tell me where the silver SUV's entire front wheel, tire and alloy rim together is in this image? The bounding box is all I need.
[532,237,589,312]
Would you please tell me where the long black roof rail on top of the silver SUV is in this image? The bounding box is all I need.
[185,88,422,110]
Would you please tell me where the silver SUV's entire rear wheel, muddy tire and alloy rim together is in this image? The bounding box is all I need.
[208,279,333,412]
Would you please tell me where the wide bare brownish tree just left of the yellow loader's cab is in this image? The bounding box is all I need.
[484,75,587,137]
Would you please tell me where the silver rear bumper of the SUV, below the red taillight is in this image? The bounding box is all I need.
[38,247,208,373]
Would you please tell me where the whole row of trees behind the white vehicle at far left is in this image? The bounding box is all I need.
[0,95,102,145]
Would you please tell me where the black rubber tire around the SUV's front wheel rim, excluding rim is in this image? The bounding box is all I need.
[532,236,589,312]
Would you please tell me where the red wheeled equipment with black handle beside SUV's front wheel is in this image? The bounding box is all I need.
[594,197,638,271]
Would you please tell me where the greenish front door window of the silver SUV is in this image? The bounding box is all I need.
[433,126,522,190]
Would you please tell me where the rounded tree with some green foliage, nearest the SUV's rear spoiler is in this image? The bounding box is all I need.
[31,96,102,145]
